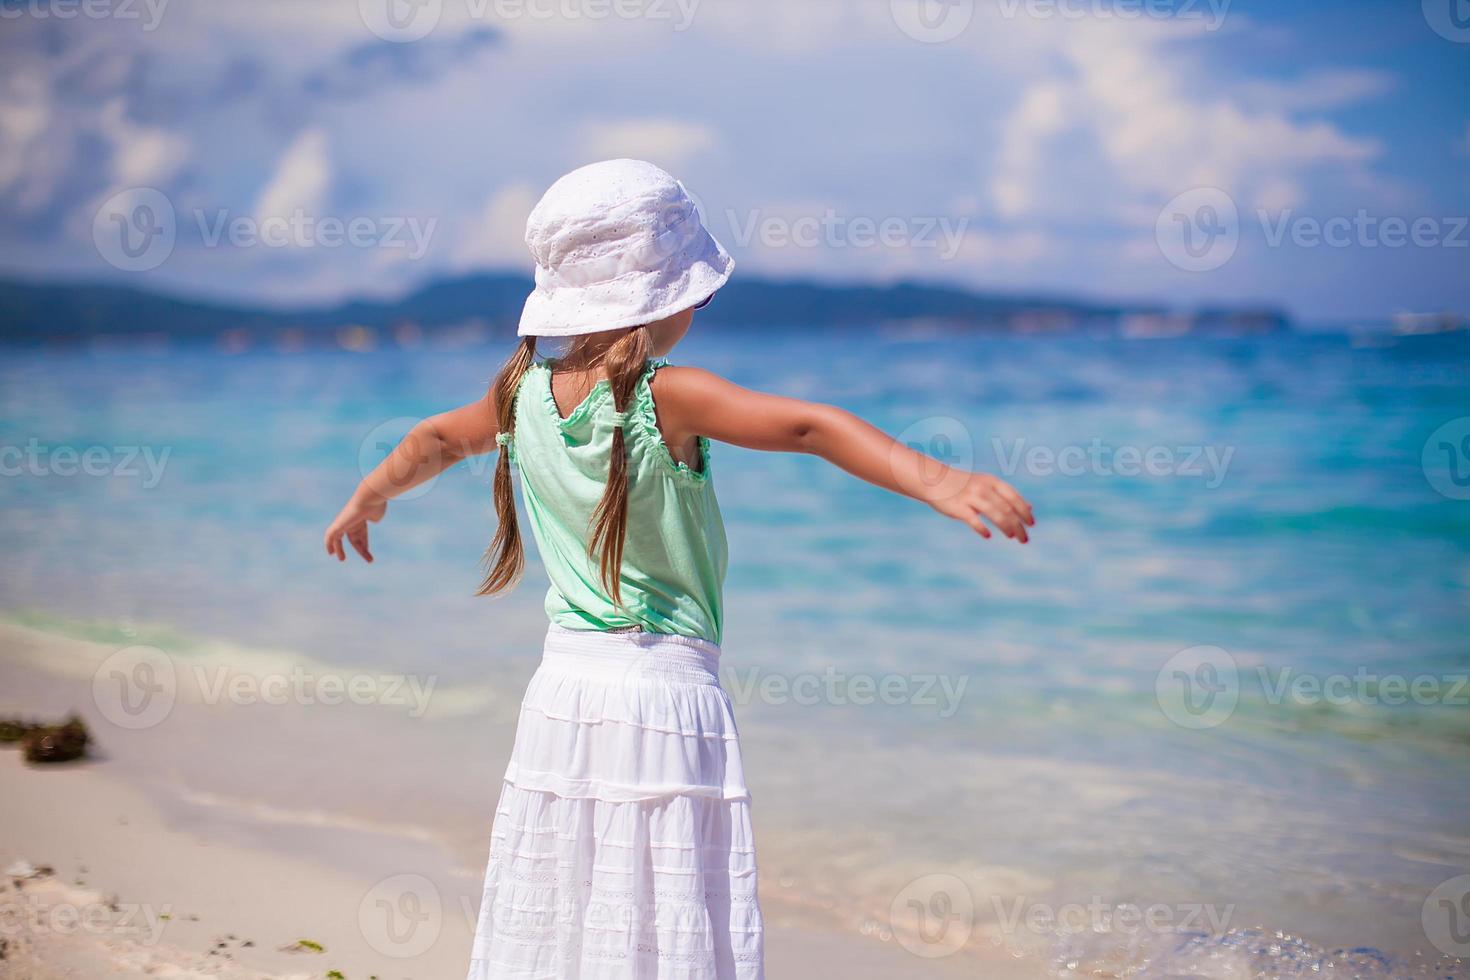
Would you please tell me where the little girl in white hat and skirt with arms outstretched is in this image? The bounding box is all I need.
[326,160,1035,980]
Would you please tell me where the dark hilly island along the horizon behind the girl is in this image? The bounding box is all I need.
[0,273,1291,350]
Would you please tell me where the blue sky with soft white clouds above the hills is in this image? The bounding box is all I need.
[0,0,1470,320]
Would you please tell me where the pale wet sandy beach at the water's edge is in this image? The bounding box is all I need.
[0,626,1036,980]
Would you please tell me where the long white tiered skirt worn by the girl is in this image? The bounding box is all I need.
[469,627,764,980]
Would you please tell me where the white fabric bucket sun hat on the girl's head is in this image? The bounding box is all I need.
[520,160,735,336]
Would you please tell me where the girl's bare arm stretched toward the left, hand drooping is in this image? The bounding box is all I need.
[325,395,500,561]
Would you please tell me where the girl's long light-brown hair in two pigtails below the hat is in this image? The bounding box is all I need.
[478,326,653,604]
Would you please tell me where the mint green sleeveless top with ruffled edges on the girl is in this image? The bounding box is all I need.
[510,361,729,644]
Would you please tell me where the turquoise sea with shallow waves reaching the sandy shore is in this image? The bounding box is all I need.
[0,329,1470,977]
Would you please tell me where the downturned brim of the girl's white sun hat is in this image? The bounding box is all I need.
[519,228,735,336]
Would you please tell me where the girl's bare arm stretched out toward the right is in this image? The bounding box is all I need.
[654,367,1036,544]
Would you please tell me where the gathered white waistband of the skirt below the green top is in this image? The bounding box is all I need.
[541,626,720,685]
